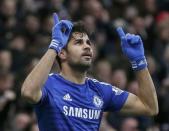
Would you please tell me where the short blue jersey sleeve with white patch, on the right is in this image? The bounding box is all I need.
[99,84,129,111]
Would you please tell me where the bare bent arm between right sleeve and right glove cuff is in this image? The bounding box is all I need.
[121,68,158,115]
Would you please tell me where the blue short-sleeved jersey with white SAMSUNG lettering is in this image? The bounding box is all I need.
[35,74,128,131]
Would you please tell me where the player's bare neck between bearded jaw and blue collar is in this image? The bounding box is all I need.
[60,66,86,84]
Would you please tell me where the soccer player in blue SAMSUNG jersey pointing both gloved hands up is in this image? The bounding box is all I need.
[21,14,158,131]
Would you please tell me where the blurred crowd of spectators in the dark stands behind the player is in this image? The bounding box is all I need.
[0,0,169,131]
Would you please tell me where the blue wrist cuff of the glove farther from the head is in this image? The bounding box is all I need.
[131,57,147,71]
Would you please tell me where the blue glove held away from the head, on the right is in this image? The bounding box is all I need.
[117,27,147,71]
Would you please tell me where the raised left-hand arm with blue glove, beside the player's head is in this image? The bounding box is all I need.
[21,13,72,103]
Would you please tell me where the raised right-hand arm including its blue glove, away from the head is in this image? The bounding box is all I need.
[117,28,158,115]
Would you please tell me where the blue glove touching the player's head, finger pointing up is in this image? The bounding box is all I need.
[49,13,73,53]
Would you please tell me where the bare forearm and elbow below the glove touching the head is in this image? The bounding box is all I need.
[21,49,57,103]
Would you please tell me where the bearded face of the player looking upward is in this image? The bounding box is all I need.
[66,32,93,71]
